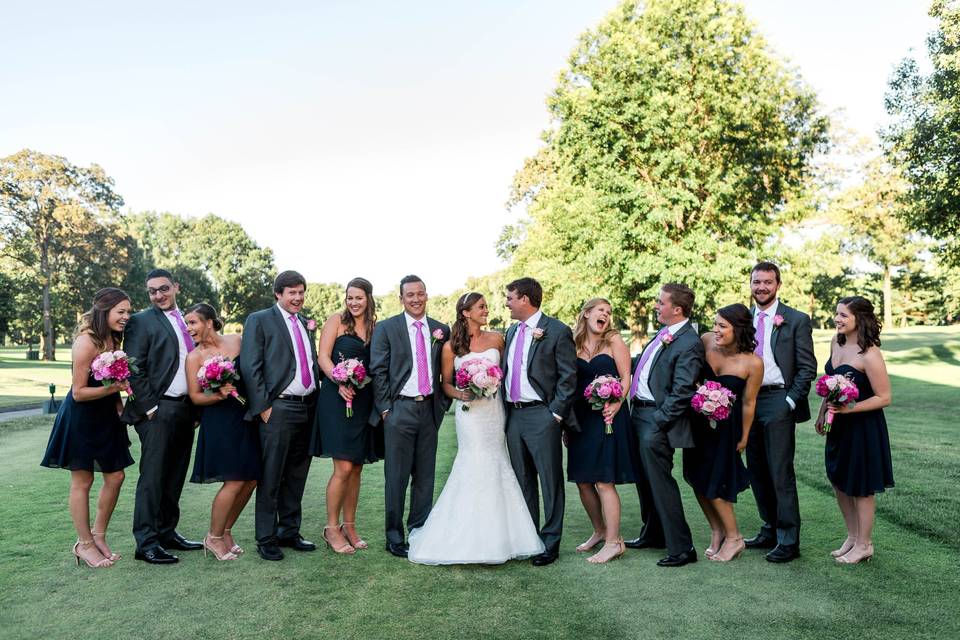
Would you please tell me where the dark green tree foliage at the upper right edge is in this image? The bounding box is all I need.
[884,0,960,265]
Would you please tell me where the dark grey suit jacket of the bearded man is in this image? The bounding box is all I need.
[750,302,817,422]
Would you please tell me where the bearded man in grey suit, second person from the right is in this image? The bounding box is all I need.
[744,262,817,562]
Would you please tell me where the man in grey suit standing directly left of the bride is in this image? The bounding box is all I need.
[370,275,450,558]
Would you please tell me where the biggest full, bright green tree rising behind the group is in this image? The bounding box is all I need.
[500,0,827,339]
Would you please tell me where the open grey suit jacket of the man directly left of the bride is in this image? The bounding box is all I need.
[370,312,451,427]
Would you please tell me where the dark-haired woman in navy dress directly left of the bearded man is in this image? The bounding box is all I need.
[683,304,763,562]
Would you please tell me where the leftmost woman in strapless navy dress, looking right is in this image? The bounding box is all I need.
[40,287,133,569]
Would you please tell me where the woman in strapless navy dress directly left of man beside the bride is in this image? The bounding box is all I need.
[310,278,379,554]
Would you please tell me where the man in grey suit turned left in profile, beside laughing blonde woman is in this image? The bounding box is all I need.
[628,284,704,567]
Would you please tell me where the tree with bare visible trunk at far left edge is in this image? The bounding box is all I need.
[0,149,127,360]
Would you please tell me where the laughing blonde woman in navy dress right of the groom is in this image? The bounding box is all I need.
[563,298,640,564]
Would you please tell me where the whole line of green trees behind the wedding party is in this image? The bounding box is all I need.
[0,0,960,359]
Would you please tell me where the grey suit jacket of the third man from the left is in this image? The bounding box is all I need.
[239,305,320,420]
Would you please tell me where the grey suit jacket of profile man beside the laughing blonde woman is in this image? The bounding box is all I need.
[631,322,705,449]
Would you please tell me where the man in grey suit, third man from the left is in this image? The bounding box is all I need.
[240,271,320,560]
